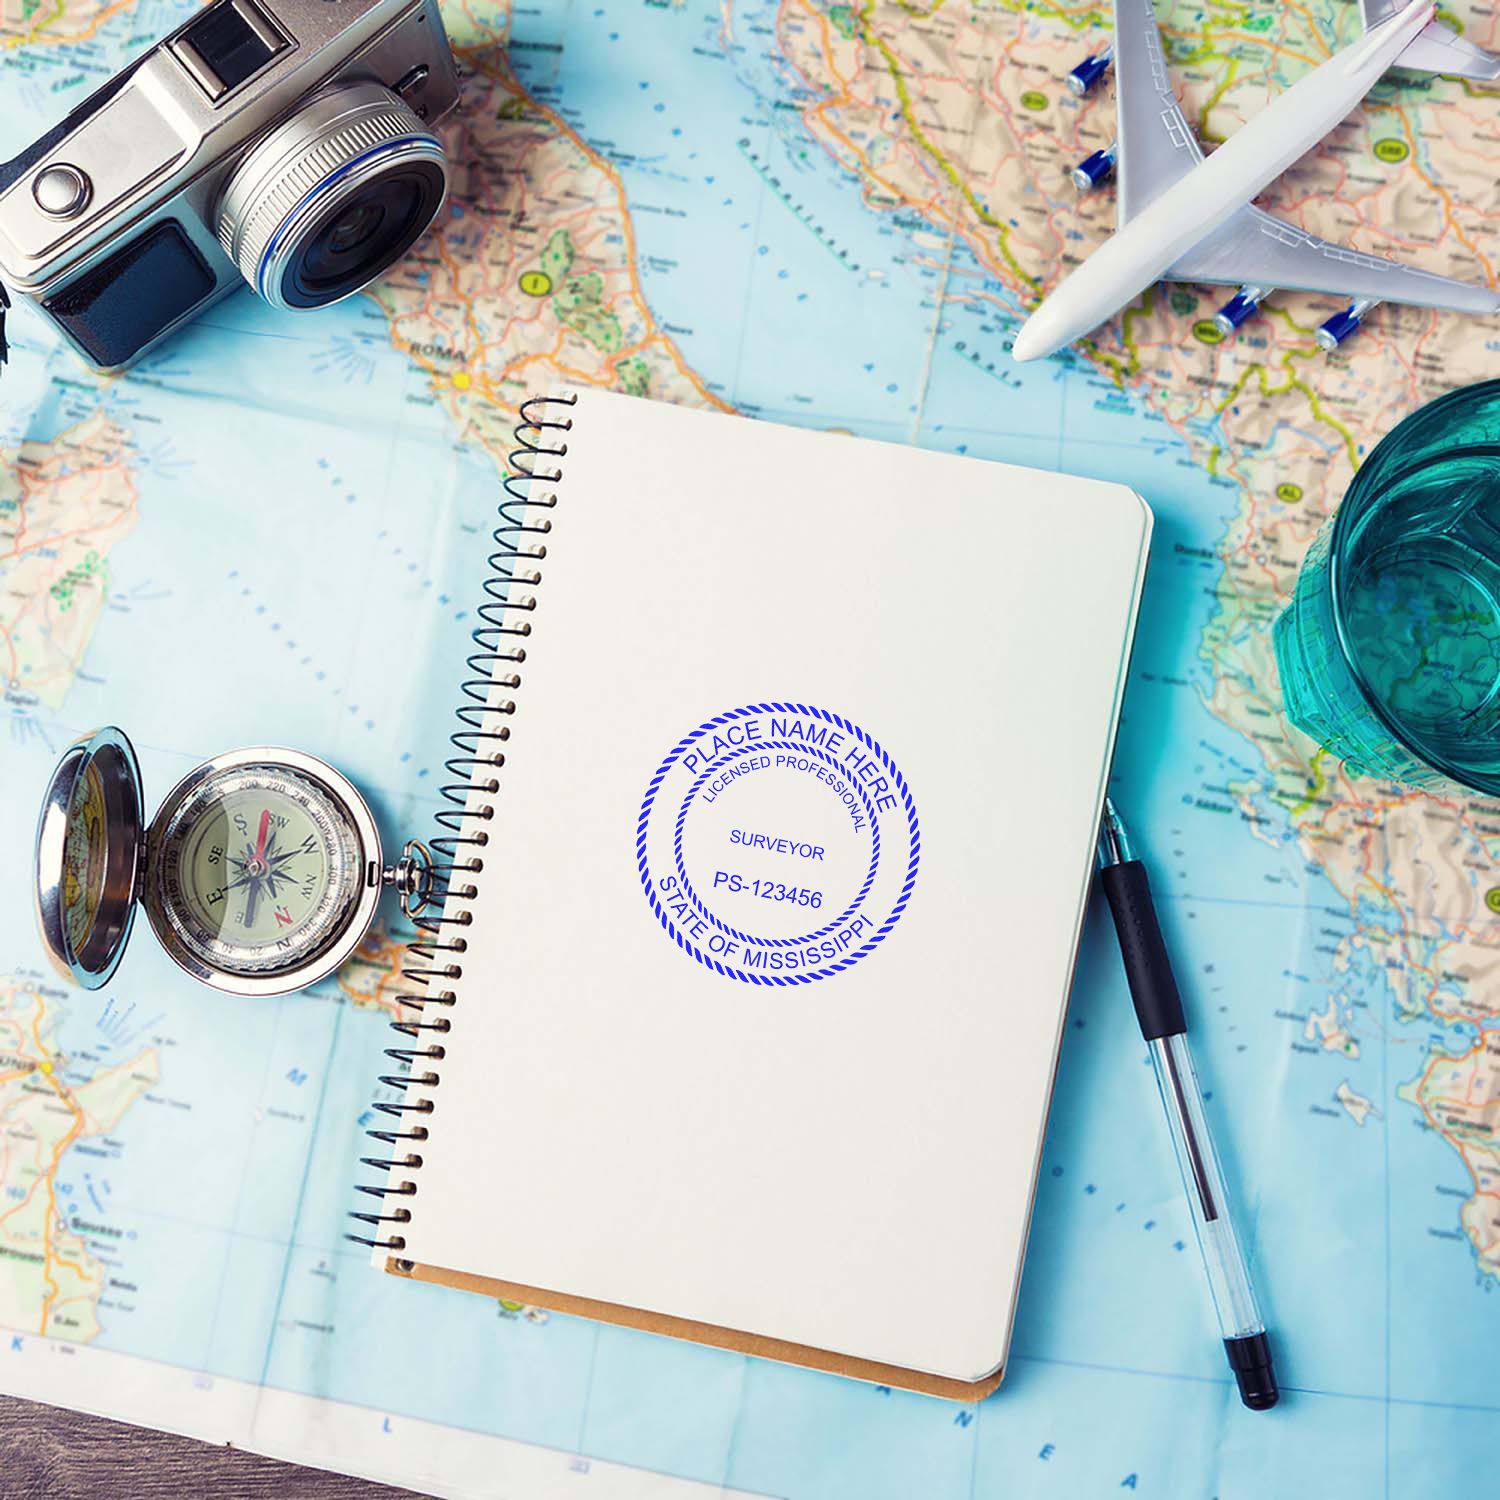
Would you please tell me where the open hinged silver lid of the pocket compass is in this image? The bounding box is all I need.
[36,728,146,990]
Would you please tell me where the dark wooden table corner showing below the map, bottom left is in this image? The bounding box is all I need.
[0,1397,426,1500]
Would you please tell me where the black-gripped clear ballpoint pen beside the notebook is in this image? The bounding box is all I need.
[1100,798,1280,1412]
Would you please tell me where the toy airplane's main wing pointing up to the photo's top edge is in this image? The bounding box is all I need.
[1115,0,1206,225]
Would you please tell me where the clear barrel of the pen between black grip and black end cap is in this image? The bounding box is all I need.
[1151,1032,1265,1338]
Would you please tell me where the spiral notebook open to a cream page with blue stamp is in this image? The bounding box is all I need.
[365,390,1151,1400]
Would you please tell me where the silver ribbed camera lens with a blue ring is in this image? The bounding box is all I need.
[219,83,447,308]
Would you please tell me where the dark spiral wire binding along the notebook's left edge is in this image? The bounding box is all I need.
[345,395,578,1271]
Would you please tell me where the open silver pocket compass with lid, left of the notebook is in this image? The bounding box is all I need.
[36,729,434,995]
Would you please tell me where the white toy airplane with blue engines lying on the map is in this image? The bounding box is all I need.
[1013,0,1500,360]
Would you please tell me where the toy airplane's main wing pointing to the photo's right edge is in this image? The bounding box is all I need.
[1164,204,1500,314]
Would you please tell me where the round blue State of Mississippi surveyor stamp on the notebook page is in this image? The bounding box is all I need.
[636,704,921,984]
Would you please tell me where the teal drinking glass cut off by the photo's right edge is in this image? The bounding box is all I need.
[1274,381,1500,795]
